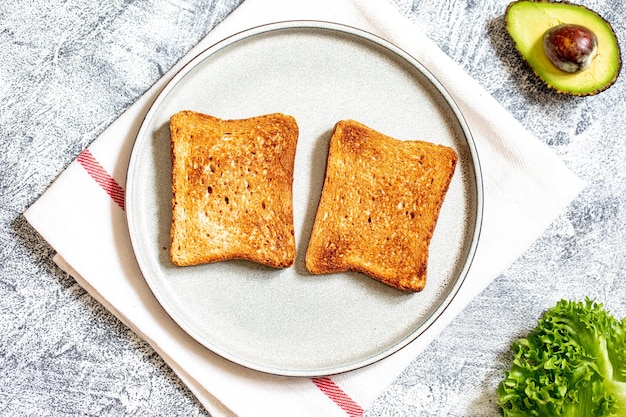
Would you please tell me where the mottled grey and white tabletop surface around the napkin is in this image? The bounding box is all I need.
[0,0,626,417]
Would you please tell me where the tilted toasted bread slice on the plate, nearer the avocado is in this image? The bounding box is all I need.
[305,120,458,291]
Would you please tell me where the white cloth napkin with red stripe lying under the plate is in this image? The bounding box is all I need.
[25,0,583,416]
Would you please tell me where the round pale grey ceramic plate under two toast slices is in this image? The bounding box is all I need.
[126,22,482,376]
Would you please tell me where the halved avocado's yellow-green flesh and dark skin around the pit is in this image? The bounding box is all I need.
[505,0,622,96]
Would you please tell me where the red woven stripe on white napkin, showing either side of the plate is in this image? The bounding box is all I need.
[77,149,364,417]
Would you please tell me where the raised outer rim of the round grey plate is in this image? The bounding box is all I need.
[125,20,484,377]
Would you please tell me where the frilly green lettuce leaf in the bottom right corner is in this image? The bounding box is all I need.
[497,298,626,417]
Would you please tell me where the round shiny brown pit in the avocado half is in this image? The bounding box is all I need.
[543,24,598,73]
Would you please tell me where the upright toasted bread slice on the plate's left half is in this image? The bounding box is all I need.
[170,111,298,268]
